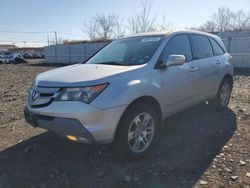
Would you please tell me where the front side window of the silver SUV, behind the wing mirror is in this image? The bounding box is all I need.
[163,35,192,61]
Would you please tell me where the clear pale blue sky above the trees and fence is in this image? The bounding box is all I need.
[0,0,250,46]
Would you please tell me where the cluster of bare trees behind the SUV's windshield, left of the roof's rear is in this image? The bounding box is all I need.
[83,0,174,40]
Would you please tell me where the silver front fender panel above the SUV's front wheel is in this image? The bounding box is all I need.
[91,71,164,109]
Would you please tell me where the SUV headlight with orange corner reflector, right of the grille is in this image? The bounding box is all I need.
[55,84,108,103]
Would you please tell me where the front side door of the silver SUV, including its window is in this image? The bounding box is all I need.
[160,34,200,115]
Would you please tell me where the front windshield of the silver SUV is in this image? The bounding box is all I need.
[87,35,163,66]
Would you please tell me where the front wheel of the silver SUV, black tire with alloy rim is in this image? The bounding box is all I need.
[115,104,160,159]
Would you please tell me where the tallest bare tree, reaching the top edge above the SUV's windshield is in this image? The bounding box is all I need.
[128,0,156,33]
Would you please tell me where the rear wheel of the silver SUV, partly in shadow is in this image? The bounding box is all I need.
[212,79,233,109]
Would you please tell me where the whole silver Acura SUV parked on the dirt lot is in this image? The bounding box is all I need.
[25,31,233,157]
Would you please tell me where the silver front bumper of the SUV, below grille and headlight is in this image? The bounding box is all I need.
[24,101,126,144]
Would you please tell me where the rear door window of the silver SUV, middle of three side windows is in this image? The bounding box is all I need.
[191,35,213,59]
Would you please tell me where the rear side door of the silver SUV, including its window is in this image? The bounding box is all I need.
[189,34,219,99]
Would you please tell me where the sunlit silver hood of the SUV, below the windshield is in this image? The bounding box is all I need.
[36,64,142,87]
